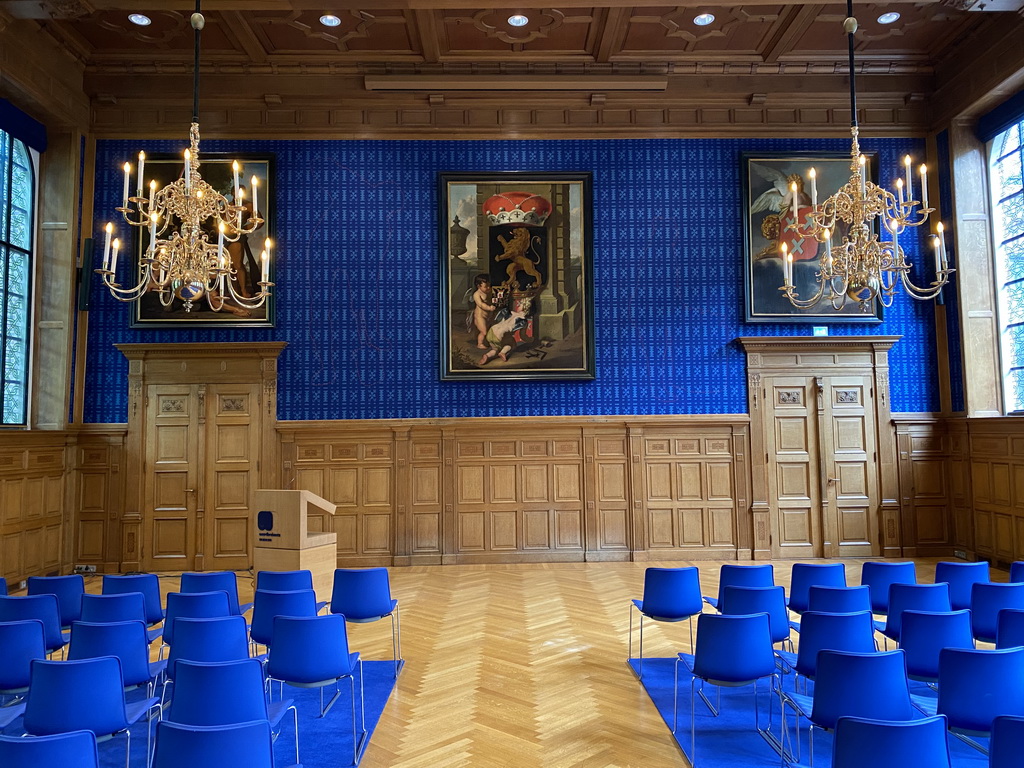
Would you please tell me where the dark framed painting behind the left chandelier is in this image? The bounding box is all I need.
[131,153,275,329]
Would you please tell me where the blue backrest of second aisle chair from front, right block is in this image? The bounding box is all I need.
[693,613,775,684]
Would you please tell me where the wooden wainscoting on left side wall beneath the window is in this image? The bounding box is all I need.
[0,431,73,589]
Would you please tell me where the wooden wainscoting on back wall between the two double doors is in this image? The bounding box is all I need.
[279,415,752,565]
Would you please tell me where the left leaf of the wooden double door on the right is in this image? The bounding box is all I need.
[764,376,821,559]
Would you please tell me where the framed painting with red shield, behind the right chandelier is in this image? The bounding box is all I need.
[741,153,882,325]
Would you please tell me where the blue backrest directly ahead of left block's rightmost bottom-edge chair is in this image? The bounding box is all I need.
[166,658,267,729]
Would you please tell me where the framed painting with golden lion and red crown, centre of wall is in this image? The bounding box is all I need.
[438,172,594,380]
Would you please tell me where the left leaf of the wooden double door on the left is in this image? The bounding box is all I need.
[142,384,202,570]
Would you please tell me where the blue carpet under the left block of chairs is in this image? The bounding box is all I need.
[3,662,395,768]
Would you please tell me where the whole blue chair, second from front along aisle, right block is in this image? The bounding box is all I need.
[672,613,777,766]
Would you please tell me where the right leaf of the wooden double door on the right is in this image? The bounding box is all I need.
[819,376,879,557]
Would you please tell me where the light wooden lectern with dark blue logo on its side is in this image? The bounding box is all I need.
[253,488,338,600]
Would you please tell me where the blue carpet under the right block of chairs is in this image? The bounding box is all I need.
[629,658,988,768]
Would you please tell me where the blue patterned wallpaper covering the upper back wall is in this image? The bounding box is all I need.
[84,138,938,423]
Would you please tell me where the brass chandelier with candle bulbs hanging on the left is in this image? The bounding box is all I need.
[96,0,273,312]
